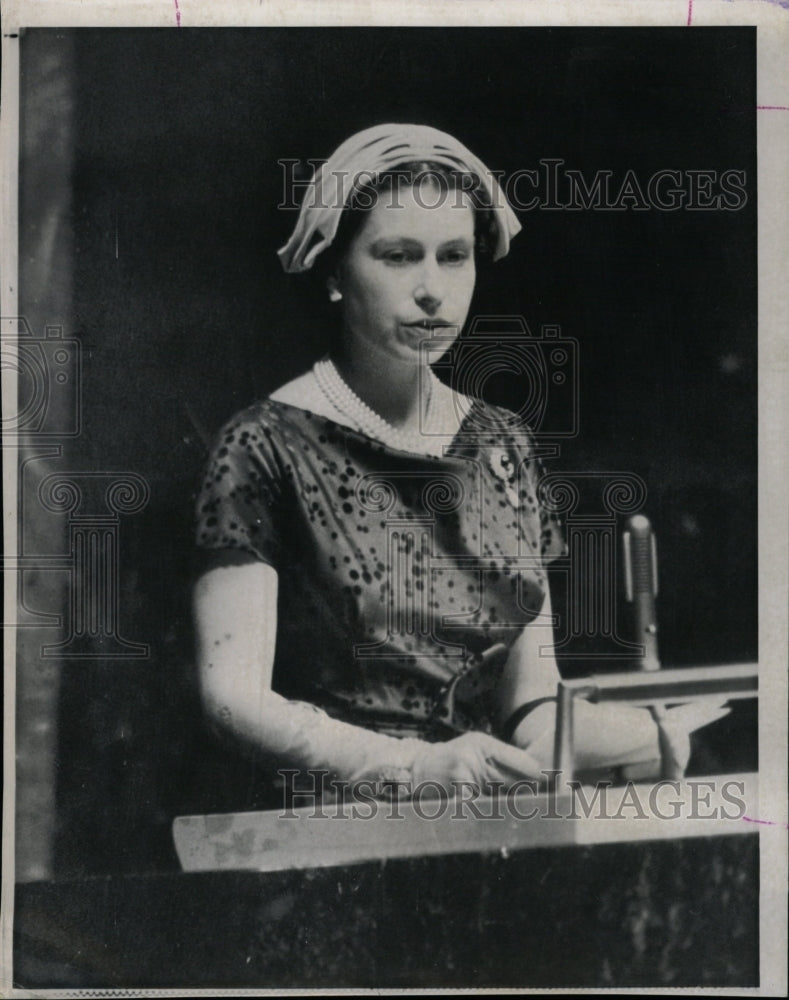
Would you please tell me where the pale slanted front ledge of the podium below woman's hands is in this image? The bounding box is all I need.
[173,774,759,872]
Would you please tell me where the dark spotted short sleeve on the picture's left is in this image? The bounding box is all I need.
[195,417,283,567]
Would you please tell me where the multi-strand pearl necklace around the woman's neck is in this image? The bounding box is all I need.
[312,358,446,456]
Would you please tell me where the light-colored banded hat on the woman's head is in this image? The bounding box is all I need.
[277,125,521,273]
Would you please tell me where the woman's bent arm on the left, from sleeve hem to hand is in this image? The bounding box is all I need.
[194,562,540,794]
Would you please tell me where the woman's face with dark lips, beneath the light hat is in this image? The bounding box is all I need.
[338,182,476,364]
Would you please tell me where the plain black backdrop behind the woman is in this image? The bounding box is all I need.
[22,28,757,876]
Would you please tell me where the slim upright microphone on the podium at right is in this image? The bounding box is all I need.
[622,514,660,670]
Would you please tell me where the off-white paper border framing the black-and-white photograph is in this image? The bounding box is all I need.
[0,0,789,996]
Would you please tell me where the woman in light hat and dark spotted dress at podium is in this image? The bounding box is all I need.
[195,125,716,794]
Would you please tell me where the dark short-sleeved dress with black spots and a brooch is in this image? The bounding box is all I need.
[196,399,564,739]
